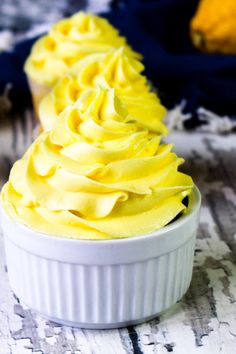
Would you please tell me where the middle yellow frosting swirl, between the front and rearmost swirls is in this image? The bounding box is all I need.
[39,48,168,135]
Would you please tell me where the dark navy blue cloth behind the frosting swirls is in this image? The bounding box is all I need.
[0,0,236,120]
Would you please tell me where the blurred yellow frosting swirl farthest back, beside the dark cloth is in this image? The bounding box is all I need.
[25,12,140,87]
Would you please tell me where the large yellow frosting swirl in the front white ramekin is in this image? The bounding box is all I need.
[1,88,193,240]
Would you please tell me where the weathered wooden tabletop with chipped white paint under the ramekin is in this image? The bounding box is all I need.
[0,112,236,354]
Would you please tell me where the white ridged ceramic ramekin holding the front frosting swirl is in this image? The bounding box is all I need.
[0,188,200,329]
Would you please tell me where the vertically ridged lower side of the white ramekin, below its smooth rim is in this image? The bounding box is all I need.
[5,233,196,328]
